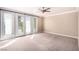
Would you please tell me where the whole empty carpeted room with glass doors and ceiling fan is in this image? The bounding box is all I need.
[0,7,79,51]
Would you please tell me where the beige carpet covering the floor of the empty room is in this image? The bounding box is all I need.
[0,33,78,51]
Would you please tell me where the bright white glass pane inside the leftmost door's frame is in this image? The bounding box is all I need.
[4,13,12,35]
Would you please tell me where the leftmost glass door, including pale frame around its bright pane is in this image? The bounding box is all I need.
[1,11,14,40]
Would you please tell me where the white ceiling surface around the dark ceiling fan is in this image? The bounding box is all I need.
[8,7,76,17]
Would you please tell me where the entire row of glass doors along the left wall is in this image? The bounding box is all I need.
[0,11,38,40]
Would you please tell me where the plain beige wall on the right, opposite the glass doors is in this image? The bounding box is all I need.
[44,12,78,38]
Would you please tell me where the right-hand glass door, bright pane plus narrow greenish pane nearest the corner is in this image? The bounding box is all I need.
[25,16,37,34]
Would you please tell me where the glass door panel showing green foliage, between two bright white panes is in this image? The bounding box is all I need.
[16,14,25,36]
